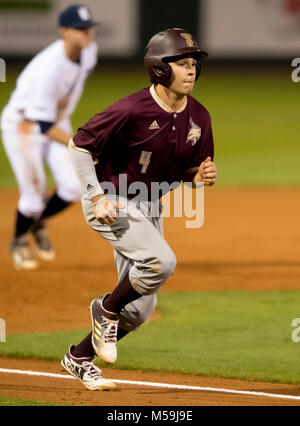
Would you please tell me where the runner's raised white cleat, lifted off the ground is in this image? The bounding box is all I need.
[90,297,119,363]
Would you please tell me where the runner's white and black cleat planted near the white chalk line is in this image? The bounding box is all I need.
[61,345,116,390]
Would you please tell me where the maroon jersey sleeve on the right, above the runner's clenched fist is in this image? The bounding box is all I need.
[185,111,214,170]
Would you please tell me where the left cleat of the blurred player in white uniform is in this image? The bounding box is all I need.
[10,235,38,271]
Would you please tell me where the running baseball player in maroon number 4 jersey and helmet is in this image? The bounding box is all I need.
[62,28,217,390]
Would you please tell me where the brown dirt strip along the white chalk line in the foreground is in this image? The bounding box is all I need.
[0,358,300,407]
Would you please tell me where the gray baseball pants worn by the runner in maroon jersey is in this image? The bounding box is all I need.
[82,194,176,331]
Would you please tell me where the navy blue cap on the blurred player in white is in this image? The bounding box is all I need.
[58,4,98,28]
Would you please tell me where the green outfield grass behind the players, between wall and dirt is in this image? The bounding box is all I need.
[0,64,300,187]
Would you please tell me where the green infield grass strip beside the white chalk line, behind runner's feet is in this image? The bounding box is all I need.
[0,291,300,384]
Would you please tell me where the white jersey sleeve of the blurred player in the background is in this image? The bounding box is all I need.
[24,69,59,123]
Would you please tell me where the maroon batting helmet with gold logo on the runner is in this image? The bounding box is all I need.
[144,28,208,84]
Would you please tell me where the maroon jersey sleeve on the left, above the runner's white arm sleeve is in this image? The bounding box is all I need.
[73,100,130,158]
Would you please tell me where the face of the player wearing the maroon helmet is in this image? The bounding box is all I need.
[168,58,197,95]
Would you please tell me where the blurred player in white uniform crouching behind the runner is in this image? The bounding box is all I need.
[1,5,98,270]
